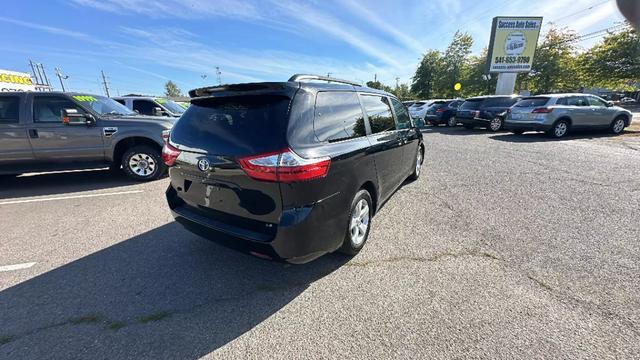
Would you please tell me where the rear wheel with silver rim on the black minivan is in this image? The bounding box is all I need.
[339,189,373,256]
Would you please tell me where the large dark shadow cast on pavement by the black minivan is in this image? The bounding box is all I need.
[0,223,348,359]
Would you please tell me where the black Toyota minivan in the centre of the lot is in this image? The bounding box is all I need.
[163,75,425,263]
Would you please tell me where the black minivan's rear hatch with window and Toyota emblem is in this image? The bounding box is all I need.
[170,94,292,240]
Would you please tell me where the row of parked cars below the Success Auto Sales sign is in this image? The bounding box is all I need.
[404,94,633,138]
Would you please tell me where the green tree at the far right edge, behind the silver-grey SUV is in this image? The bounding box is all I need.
[578,27,640,90]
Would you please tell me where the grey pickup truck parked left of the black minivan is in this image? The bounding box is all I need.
[0,92,175,181]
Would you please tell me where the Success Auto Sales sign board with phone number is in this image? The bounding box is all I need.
[487,17,542,73]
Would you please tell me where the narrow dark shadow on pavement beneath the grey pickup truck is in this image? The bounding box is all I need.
[0,169,137,199]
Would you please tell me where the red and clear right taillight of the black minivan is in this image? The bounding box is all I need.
[238,149,331,183]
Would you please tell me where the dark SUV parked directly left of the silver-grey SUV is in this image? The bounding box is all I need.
[456,95,520,132]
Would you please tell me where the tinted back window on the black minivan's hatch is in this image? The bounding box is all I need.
[171,95,290,156]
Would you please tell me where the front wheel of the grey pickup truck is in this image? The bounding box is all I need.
[121,145,167,181]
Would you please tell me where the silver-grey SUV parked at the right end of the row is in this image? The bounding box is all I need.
[505,94,633,138]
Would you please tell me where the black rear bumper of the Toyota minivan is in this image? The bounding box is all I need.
[166,186,348,263]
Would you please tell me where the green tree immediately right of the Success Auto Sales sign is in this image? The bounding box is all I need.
[520,27,581,94]
